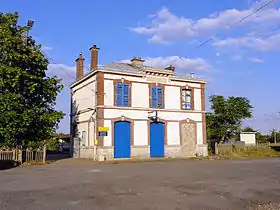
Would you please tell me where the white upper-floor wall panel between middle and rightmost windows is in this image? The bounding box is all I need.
[164,86,181,109]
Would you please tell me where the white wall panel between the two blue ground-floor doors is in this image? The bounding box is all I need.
[134,121,148,146]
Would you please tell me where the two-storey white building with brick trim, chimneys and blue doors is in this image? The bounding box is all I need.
[70,45,208,160]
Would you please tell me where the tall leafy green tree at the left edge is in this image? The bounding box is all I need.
[0,13,64,147]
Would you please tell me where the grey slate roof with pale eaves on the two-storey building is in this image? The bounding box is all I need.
[70,62,206,88]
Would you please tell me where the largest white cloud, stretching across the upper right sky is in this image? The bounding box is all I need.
[130,1,280,44]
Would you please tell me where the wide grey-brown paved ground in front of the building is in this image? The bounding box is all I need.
[0,159,280,210]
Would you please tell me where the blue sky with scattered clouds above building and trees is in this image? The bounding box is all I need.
[1,0,280,133]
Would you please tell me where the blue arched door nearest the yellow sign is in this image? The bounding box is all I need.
[114,121,130,158]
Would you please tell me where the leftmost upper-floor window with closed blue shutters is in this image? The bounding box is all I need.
[116,82,130,107]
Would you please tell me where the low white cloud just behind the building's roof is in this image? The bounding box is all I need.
[121,56,213,72]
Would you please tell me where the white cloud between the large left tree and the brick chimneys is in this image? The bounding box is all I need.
[47,64,76,85]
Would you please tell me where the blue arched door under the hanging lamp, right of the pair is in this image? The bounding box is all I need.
[150,122,164,157]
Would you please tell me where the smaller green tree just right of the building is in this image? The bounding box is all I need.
[206,95,253,141]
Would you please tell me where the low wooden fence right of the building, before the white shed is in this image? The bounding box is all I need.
[215,142,280,155]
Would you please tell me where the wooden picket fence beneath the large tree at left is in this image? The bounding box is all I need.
[0,147,46,163]
